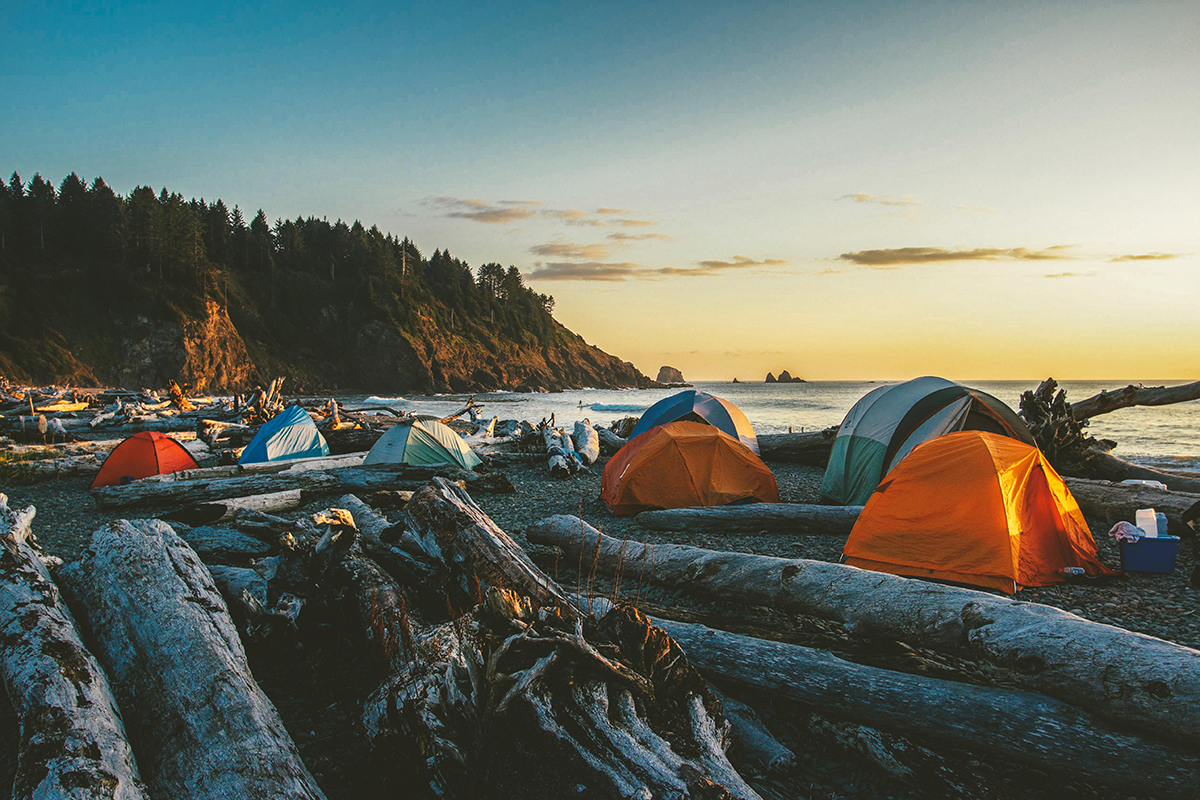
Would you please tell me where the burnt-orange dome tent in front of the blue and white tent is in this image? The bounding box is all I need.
[600,421,779,515]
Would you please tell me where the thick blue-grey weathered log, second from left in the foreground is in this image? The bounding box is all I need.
[59,519,324,800]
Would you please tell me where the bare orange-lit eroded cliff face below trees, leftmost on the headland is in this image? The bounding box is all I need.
[113,301,254,392]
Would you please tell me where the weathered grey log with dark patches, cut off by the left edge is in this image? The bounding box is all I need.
[0,494,146,800]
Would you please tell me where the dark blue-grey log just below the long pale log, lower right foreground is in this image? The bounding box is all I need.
[653,619,1200,798]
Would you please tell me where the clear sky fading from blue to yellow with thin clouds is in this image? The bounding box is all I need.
[0,0,1200,381]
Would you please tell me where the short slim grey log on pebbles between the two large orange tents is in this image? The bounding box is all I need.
[636,503,863,536]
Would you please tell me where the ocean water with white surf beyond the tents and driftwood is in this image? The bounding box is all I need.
[346,380,1200,470]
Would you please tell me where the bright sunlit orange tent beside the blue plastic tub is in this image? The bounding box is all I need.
[844,431,1112,594]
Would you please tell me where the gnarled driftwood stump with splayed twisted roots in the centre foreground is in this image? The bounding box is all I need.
[340,479,758,799]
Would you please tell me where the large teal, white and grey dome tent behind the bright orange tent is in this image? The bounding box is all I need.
[821,375,1034,505]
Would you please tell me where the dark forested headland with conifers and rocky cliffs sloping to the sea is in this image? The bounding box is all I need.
[0,173,657,393]
